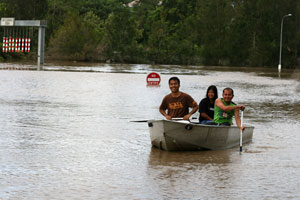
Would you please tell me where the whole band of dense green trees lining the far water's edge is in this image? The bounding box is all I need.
[0,0,300,67]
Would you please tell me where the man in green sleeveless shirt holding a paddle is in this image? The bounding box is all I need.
[214,88,245,130]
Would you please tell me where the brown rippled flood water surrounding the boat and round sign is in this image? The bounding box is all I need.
[0,64,300,200]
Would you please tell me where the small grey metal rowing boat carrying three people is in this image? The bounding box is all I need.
[147,119,254,151]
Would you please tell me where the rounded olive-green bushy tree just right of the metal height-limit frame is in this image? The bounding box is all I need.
[49,12,103,60]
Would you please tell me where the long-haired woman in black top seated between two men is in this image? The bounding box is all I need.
[199,85,218,124]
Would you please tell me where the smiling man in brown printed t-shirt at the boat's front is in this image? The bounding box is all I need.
[159,77,198,120]
